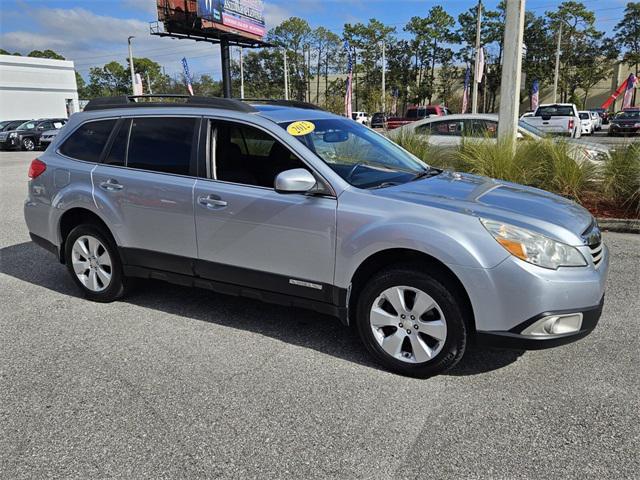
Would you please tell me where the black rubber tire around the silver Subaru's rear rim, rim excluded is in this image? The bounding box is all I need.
[64,224,129,303]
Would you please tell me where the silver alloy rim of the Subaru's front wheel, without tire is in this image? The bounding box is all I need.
[369,286,447,363]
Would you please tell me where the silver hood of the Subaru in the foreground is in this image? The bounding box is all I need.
[373,171,593,245]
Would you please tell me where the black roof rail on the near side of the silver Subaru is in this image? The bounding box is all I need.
[84,94,256,113]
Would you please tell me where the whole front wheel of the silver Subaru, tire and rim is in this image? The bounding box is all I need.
[356,267,467,378]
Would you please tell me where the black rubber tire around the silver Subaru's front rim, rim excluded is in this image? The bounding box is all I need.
[356,266,468,378]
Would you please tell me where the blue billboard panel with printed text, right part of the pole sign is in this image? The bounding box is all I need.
[198,0,267,38]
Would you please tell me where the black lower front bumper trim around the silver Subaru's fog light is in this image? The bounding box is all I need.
[476,296,604,350]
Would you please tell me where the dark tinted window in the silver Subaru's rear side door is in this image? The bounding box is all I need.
[127,117,196,175]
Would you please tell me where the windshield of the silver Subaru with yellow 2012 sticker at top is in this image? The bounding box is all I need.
[280,118,429,188]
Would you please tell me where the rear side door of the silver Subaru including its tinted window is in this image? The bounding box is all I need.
[93,116,200,274]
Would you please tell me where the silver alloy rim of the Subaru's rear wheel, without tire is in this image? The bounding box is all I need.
[71,235,113,292]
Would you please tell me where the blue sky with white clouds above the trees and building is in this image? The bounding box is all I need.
[0,0,627,79]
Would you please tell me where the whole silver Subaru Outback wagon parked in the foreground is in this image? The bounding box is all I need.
[24,97,609,377]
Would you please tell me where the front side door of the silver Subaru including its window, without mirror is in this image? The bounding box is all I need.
[194,122,337,301]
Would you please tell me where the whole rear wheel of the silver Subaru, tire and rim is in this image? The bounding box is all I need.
[64,224,126,302]
